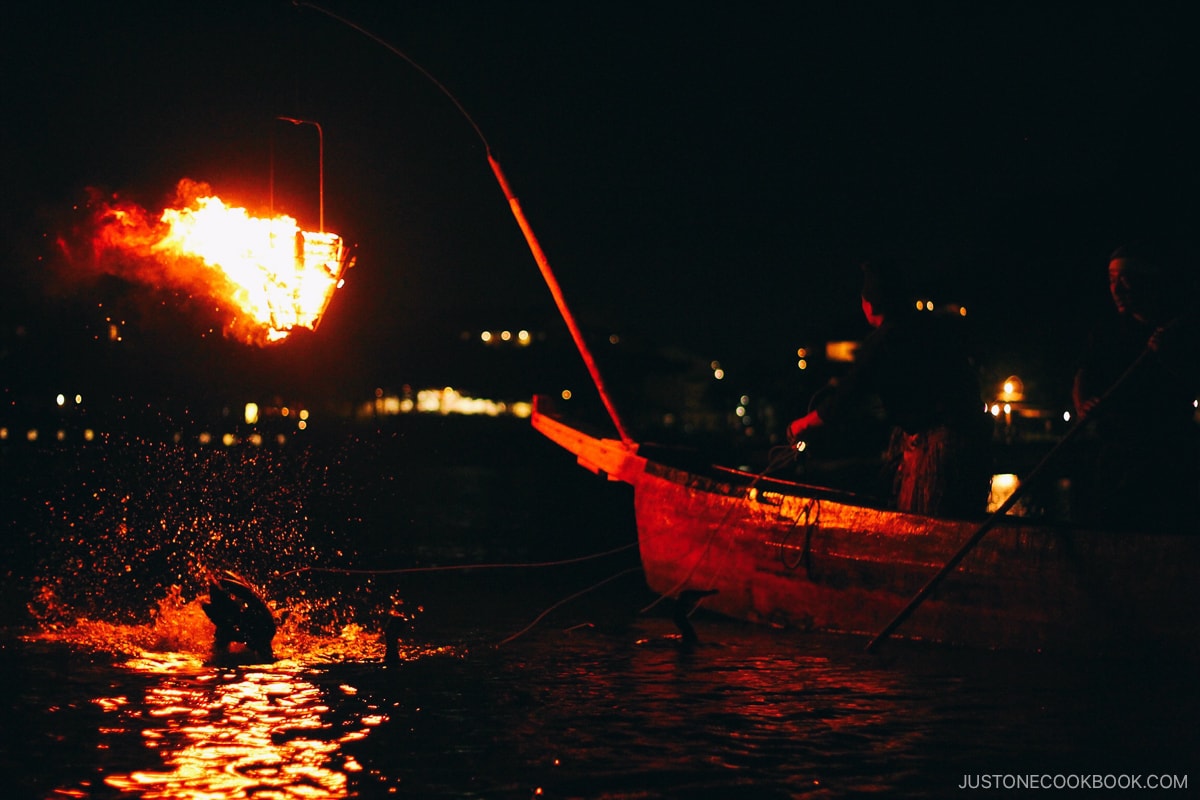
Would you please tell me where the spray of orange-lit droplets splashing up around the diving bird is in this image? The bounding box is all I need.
[6,437,415,660]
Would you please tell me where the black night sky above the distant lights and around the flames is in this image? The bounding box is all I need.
[0,0,1198,407]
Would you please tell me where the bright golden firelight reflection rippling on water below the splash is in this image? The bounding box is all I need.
[97,672,378,800]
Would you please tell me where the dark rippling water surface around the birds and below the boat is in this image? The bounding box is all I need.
[0,420,1200,799]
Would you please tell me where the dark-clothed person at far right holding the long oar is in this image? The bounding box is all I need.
[1072,242,1200,528]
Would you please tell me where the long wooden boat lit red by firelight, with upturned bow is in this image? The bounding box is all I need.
[533,402,1200,657]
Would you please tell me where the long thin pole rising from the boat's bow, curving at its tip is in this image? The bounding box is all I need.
[292,0,634,447]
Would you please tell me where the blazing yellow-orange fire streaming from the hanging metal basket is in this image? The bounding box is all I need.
[87,180,353,342]
